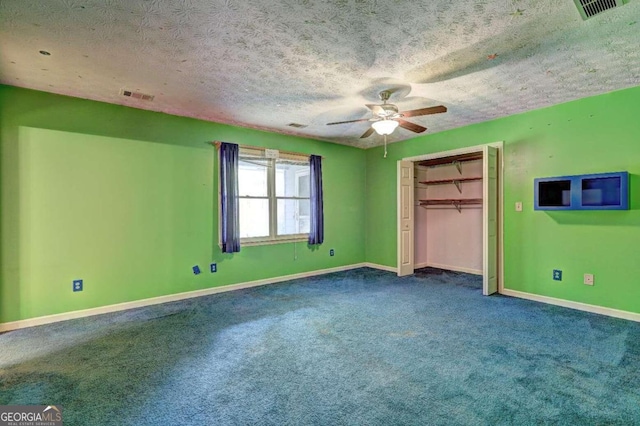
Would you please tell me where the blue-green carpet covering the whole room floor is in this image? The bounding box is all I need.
[0,268,640,425]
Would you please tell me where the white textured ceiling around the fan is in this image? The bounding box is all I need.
[0,0,640,148]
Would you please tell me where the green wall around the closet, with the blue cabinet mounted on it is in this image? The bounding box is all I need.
[365,87,640,312]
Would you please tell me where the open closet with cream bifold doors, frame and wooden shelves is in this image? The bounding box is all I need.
[398,142,503,295]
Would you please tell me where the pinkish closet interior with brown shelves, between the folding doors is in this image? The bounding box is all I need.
[414,158,482,274]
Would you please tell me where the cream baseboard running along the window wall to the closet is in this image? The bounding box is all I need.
[0,262,370,332]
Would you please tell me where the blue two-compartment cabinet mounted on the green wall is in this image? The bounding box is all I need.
[534,172,629,210]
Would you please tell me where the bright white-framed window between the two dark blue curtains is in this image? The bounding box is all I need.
[238,147,311,244]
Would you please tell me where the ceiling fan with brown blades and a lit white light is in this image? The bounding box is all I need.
[327,90,447,138]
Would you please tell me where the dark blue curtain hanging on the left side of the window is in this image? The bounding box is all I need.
[220,142,240,253]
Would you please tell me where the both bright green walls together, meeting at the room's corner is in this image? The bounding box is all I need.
[5,82,640,323]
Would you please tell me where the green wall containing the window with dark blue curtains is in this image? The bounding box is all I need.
[0,86,366,323]
